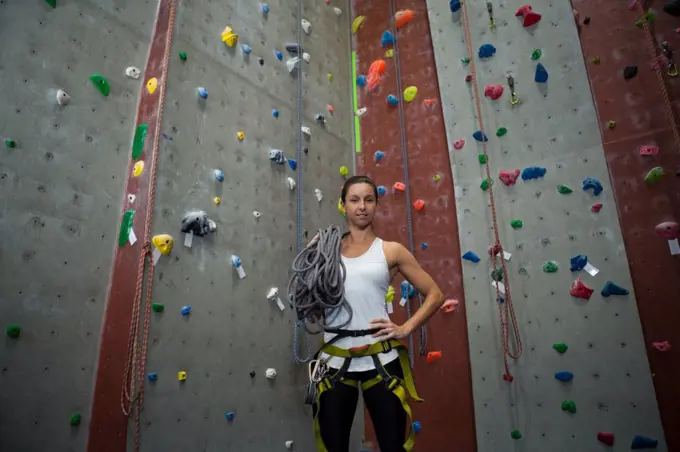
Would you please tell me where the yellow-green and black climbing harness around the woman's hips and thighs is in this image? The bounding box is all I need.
[305,329,423,452]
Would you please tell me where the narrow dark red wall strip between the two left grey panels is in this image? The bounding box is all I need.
[87,0,173,452]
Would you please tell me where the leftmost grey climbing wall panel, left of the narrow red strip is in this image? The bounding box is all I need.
[0,0,155,451]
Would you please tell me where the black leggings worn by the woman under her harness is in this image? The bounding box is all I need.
[314,359,406,452]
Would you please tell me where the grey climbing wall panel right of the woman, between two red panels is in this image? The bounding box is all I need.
[428,1,665,452]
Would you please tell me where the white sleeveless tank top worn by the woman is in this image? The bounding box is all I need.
[321,238,399,372]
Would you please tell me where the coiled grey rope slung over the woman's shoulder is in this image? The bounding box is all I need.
[288,225,352,334]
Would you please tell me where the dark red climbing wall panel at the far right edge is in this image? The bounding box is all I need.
[572,0,680,450]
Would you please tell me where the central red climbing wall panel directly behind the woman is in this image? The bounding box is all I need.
[353,0,477,452]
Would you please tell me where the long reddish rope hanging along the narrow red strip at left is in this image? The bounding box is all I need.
[120,0,176,451]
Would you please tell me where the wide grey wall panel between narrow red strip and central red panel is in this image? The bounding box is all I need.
[140,1,356,451]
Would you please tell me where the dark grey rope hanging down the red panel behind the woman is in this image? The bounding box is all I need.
[389,0,427,366]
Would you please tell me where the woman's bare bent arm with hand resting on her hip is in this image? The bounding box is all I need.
[371,242,444,339]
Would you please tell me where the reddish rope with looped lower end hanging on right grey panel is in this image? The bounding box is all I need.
[462,2,522,382]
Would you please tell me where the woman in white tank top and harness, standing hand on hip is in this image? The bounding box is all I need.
[315,176,443,452]
